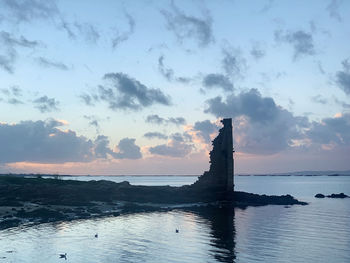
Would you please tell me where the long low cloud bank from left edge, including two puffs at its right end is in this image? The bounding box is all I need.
[0,119,142,163]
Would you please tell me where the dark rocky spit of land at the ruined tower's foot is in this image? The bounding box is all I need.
[0,176,306,229]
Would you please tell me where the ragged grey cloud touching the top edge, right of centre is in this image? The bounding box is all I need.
[161,1,214,47]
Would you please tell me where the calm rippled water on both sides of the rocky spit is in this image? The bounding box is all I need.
[0,176,350,263]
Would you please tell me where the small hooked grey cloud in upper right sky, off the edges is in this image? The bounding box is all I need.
[275,30,316,60]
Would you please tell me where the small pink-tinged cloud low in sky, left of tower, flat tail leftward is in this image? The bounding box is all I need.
[149,133,194,158]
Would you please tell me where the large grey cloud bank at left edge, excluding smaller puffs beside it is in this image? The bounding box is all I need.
[0,120,93,163]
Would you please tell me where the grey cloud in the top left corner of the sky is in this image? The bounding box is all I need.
[1,0,58,23]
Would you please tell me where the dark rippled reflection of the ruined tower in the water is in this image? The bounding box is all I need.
[189,205,236,263]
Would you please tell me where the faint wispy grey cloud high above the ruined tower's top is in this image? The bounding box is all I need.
[222,47,247,78]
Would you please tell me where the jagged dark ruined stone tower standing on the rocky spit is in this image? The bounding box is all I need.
[194,118,234,192]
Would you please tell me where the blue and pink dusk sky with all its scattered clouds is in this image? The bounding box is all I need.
[0,0,350,175]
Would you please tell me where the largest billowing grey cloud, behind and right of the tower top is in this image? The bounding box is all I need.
[205,89,308,154]
